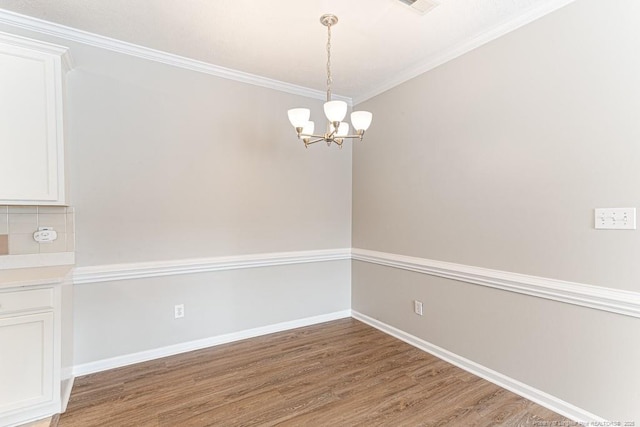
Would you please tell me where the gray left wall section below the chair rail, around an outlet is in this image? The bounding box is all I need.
[74,260,351,365]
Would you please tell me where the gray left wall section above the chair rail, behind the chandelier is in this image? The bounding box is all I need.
[69,47,351,267]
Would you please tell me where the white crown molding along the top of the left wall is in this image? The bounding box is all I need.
[0,9,353,106]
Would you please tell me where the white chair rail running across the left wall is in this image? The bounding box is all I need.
[73,249,351,285]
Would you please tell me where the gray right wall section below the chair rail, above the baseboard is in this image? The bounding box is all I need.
[352,261,640,421]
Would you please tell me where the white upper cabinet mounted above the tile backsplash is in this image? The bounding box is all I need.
[0,33,70,205]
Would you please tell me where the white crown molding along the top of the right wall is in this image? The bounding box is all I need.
[353,0,575,105]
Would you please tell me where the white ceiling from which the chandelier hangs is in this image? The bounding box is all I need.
[0,0,573,101]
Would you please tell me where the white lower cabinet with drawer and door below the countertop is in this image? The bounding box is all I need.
[0,287,60,427]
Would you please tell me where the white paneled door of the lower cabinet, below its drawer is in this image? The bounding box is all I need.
[0,312,53,413]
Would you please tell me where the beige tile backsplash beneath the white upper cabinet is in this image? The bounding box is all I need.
[0,206,75,256]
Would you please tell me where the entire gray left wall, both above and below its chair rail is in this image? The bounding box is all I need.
[0,21,351,364]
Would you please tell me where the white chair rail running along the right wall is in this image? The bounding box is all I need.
[351,248,640,317]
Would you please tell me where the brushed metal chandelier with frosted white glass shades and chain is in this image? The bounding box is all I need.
[287,14,373,148]
